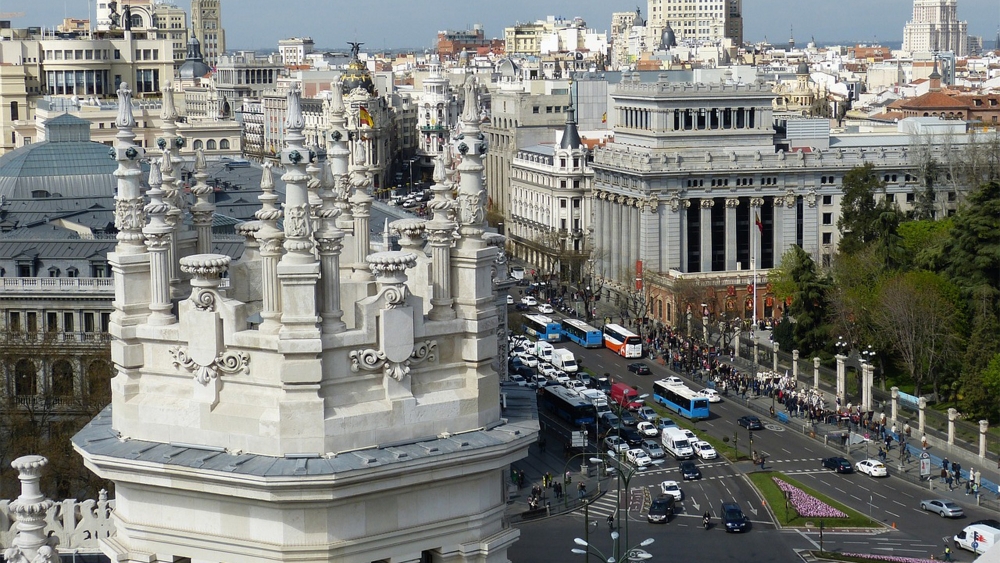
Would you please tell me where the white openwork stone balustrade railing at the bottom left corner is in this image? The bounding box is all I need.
[0,494,115,553]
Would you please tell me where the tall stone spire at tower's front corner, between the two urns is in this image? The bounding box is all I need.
[278,82,320,339]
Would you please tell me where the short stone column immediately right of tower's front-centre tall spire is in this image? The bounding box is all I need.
[315,162,347,334]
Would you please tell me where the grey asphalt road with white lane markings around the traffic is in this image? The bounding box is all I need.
[510,332,996,562]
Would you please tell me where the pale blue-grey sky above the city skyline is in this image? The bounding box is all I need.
[7,0,1000,50]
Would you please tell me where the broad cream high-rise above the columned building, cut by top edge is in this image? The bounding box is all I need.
[647,0,743,45]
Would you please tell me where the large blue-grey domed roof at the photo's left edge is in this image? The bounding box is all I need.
[0,114,118,199]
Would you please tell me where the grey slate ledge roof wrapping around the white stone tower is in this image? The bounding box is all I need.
[73,396,538,477]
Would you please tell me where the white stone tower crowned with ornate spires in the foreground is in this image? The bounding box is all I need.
[74,75,537,563]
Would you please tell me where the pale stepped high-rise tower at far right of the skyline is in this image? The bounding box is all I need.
[903,0,969,57]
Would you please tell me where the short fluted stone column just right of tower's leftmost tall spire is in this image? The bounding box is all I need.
[143,162,177,325]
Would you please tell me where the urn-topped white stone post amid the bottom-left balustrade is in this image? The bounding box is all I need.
[4,455,59,563]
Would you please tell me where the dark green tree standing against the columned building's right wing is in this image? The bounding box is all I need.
[837,163,891,254]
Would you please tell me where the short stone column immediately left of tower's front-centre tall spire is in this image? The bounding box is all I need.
[254,162,285,334]
